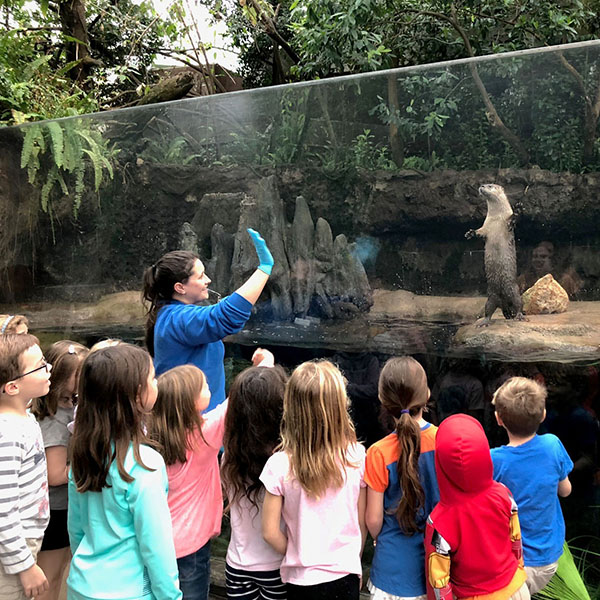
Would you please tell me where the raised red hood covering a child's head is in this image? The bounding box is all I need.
[435,414,494,505]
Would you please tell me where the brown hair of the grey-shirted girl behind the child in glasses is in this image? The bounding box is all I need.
[31,340,89,421]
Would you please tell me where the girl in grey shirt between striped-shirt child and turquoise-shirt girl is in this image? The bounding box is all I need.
[31,340,89,600]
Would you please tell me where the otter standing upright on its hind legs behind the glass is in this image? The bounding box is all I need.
[465,183,525,326]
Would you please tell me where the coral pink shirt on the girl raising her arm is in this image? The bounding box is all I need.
[167,401,228,558]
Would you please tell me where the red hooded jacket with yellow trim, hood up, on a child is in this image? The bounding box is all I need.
[425,415,526,599]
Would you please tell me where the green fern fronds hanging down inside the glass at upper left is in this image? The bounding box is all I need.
[21,119,118,217]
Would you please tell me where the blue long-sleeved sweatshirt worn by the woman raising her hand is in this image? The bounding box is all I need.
[154,292,252,412]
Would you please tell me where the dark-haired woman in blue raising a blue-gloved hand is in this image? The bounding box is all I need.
[142,229,273,411]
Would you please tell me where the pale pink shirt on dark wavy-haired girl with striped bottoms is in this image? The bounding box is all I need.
[227,492,283,571]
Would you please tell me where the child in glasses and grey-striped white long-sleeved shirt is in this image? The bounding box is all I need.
[0,334,51,600]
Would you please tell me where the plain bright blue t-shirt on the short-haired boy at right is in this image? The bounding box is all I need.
[492,433,573,567]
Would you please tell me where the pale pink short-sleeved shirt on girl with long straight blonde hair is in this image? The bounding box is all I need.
[260,444,366,585]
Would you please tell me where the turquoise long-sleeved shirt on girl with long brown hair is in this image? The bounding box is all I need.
[67,445,182,600]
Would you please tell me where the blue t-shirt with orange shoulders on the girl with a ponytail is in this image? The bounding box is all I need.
[365,424,440,597]
